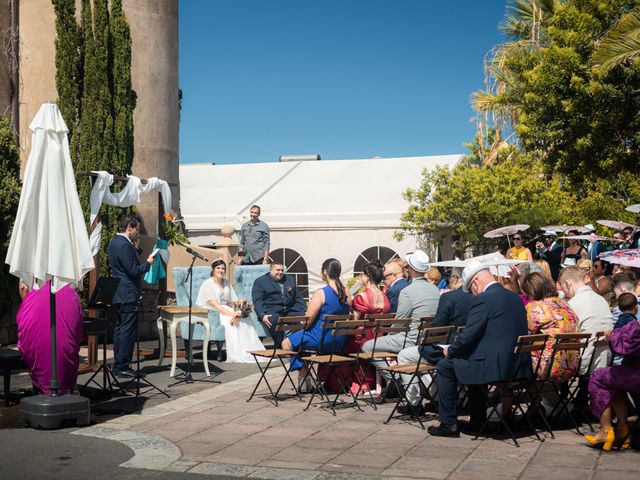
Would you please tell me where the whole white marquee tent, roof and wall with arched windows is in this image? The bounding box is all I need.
[180,155,463,291]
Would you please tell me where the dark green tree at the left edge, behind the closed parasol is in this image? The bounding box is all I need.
[0,117,21,317]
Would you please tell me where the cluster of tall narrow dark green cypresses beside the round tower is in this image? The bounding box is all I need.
[52,0,136,275]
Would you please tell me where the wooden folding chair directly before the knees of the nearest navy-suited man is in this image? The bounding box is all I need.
[384,325,453,430]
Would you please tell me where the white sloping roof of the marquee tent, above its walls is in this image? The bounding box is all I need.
[180,155,463,231]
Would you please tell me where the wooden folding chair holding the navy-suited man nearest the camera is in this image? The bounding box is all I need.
[475,334,553,447]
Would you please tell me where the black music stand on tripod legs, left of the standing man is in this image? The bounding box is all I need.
[78,277,127,395]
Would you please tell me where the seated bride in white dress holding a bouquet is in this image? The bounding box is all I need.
[196,259,264,363]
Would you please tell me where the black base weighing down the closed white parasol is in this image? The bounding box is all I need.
[20,394,91,430]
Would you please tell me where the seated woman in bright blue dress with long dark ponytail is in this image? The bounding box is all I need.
[282,258,350,390]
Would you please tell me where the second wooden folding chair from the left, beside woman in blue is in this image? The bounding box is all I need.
[302,322,369,416]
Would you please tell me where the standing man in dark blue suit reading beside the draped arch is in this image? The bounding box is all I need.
[107,215,153,378]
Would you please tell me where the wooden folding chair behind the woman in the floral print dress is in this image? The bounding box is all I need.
[546,333,595,435]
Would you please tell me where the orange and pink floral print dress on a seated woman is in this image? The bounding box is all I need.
[526,297,580,382]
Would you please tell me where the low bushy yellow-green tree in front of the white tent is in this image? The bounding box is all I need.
[399,152,577,250]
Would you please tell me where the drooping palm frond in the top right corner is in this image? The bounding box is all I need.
[591,7,640,69]
